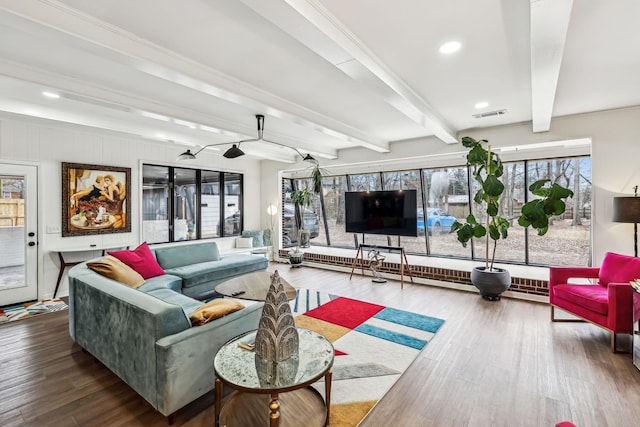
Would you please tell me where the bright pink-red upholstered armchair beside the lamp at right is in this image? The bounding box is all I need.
[549,252,640,352]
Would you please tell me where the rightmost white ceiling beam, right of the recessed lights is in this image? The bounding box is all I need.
[531,0,576,132]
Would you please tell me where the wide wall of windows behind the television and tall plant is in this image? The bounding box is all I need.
[282,156,591,266]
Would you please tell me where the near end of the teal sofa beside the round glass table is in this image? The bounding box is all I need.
[156,303,264,415]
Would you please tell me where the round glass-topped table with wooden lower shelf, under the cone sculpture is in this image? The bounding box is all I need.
[214,328,334,427]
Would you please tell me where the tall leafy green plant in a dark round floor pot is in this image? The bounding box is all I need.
[451,136,573,301]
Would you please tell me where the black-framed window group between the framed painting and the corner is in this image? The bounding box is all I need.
[142,164,242,243]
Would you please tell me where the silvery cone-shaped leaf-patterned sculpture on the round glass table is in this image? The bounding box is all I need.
[255,270,298,362]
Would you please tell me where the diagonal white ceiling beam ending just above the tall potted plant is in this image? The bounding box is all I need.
[278,0,458,144]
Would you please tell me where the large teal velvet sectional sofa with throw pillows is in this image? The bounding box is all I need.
[69,243,267,422]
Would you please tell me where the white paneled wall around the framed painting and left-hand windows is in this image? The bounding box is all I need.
[0,113,263,298]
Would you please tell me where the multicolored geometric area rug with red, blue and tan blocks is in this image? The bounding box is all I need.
[291,289,444,427]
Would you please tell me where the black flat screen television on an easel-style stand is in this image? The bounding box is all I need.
[345,190,418,237]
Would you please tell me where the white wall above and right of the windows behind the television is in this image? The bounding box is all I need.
[262,106,640,265]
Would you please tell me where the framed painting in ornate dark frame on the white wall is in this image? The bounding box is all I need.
[62,162,131,237]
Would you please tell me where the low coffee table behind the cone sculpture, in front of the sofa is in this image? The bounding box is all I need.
[215,271,296,301]
